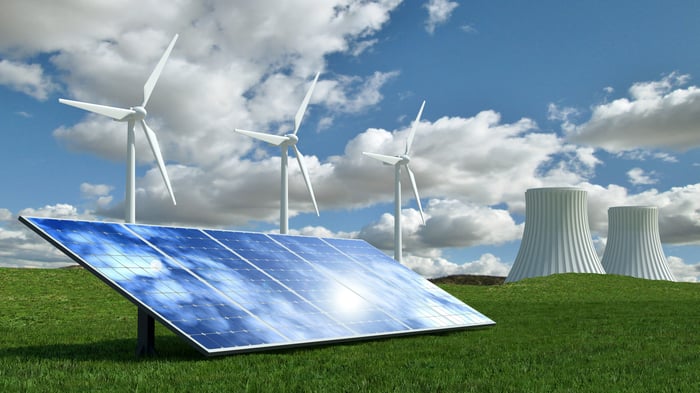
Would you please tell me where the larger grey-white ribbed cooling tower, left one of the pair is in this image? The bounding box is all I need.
[506,187,605,282]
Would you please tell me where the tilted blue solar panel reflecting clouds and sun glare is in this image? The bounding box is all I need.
[20,217,494,355]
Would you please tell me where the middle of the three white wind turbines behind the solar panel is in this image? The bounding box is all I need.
[234,72,321,234]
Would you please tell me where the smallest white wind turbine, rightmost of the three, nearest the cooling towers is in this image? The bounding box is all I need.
[362,101,425,263]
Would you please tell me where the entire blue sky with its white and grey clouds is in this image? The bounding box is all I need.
[0,0,700,281]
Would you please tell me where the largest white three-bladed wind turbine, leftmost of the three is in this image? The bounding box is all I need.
[58,34,178,223]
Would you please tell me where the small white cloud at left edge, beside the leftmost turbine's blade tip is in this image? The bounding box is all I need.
[0,59,56,101]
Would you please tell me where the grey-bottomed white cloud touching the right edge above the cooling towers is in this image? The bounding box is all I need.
[569,73,700,152]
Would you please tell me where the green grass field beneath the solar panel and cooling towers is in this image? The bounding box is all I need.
[0,269,700,392]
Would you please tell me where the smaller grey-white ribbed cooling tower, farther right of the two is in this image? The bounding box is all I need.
[602,206,676,281]
